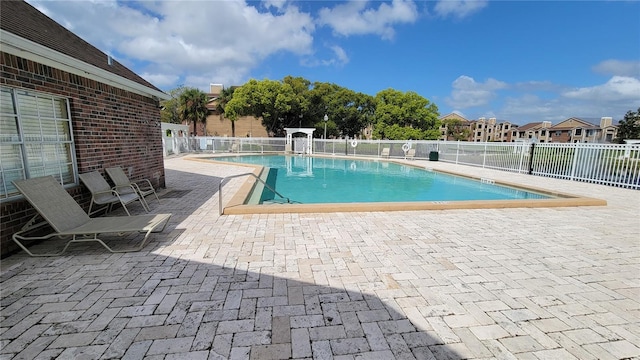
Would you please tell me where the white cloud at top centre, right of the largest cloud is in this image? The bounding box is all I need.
[318,0,418,39]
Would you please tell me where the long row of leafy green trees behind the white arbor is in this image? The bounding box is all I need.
[224,76,440,140]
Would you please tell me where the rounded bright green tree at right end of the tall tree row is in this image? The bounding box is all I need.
[373,89,440,140]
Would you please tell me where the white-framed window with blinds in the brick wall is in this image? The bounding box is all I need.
[0,87,77,199]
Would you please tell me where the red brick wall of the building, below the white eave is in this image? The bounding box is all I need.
[0,52,165,255]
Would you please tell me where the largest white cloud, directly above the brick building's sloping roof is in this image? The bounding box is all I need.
[30,0,315,89]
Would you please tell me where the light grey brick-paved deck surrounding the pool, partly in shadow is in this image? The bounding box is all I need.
[0,156,640,360]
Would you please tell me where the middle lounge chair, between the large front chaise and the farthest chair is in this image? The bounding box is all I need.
[79,171,149,216]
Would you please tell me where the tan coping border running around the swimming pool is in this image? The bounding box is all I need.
[187,153,607,215]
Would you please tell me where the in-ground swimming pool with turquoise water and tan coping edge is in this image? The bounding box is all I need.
[199,155,607,215]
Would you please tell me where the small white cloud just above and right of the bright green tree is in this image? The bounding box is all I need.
[445,75,507,109]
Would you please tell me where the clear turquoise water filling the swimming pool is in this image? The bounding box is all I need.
[212,155,551,204]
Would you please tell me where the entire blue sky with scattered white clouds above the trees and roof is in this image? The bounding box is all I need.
[28,0,640,125]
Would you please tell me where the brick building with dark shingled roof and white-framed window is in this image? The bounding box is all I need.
[0,1,169,255]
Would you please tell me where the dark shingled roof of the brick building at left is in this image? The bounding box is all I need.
[0,0,162,91]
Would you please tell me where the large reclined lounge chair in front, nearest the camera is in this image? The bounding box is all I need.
[13,176,171,256]
